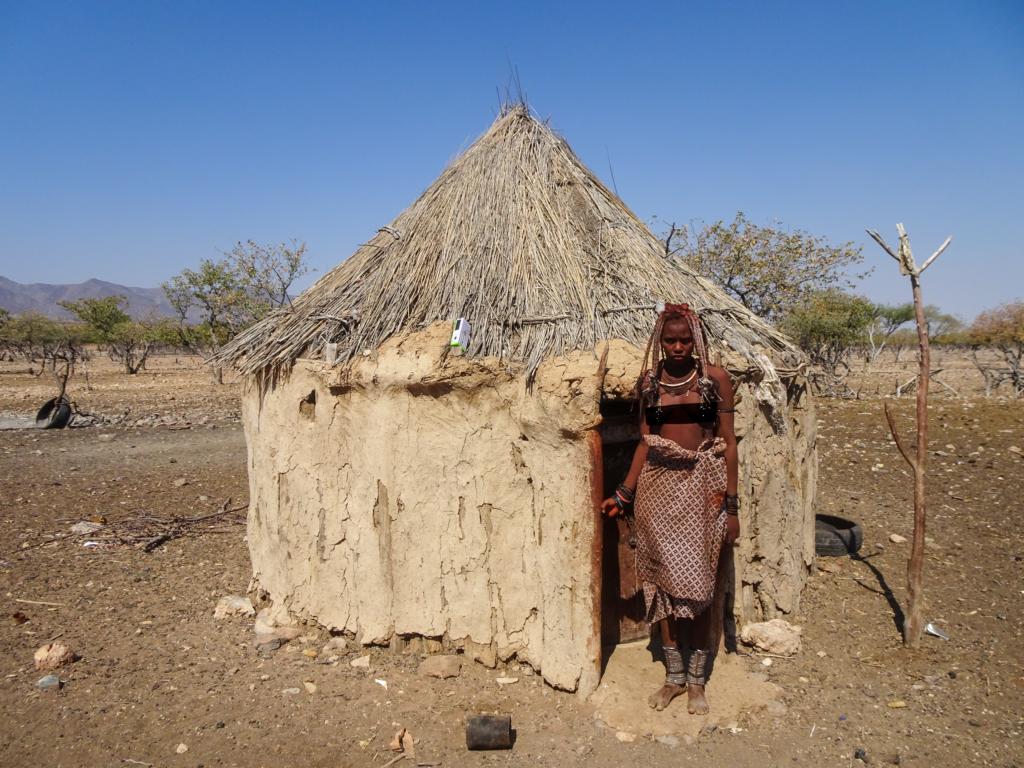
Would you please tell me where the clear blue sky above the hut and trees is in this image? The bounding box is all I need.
[0,0,1024,318]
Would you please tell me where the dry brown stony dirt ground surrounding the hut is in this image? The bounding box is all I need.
[0,358,1024,768]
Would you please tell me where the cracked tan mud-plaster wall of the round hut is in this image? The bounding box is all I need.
[243,324,814,693]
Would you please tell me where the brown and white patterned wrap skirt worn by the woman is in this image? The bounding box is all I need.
[634,435,726,624]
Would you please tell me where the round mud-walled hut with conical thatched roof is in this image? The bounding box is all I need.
[220,106,815,691]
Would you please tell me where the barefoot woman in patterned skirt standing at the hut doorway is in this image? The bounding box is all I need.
[602,304,739,714]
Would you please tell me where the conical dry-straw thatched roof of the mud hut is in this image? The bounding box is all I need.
[213,105,794,378]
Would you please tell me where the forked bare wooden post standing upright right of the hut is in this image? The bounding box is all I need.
[867,224,952,648]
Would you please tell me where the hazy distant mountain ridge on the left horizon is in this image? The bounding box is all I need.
[0,275,174,319]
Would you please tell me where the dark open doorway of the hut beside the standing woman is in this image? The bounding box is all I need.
[601,400,648,655]
